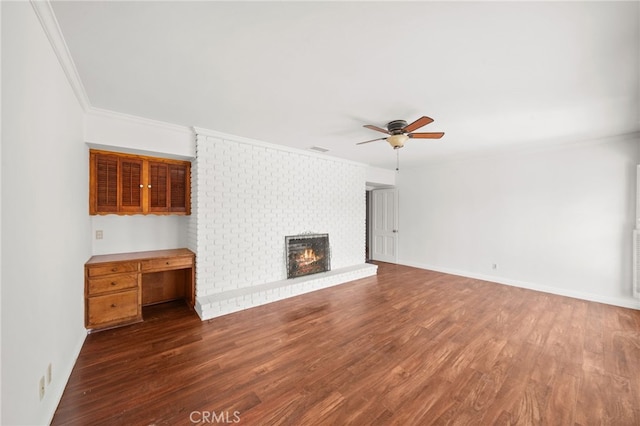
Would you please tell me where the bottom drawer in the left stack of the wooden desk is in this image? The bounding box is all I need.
[87,289,139,326]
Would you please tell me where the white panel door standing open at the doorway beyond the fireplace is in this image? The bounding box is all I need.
[371,189,398,263]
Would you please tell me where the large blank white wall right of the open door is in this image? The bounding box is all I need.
[398,135,640,307]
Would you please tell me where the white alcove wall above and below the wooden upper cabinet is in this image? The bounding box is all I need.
[84,108,195,254]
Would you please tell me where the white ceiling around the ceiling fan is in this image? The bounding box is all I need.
[52,1,640,168]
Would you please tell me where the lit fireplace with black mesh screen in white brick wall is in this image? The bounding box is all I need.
[285,234,331,278]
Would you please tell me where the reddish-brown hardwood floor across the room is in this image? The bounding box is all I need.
[53,264,640,426]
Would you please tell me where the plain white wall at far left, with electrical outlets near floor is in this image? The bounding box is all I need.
[1,2,91,425]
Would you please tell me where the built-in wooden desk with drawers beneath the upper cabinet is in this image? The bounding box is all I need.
[84,249,195,330]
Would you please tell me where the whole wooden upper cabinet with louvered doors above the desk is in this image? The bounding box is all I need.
[89,150,191,215]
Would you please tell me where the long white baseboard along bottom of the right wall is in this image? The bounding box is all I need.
[399,262,640,310]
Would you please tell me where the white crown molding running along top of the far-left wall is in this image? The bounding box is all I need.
[30,0,91,112]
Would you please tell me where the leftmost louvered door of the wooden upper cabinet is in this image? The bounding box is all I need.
[89,153,118,214]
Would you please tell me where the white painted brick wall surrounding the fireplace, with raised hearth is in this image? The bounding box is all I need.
[189,135,375,318]
